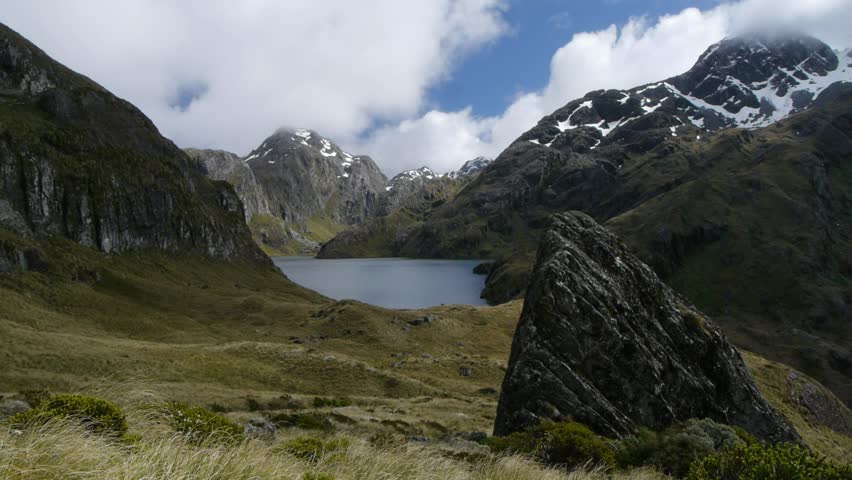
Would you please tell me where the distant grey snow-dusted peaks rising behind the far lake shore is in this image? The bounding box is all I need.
[186,133,490,255]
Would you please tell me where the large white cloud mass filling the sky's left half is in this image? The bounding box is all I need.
[0,0,506,161]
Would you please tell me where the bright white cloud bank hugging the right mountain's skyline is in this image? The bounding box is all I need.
[363,0,852,175]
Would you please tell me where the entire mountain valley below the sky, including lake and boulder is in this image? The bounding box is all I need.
[0,10,852,480]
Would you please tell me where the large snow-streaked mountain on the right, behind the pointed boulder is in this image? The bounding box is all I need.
[318,36,852,403]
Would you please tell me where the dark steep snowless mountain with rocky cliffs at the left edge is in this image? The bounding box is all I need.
[0,25,268,267]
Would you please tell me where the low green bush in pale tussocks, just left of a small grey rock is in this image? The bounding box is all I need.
[165,402,243,443]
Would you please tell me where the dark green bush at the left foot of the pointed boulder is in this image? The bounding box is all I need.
[484,422,615,467]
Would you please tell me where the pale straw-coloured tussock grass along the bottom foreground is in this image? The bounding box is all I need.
[0,386,666,480]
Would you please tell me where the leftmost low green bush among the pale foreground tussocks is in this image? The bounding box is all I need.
[7,394,127,436]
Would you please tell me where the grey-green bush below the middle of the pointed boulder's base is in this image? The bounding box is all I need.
[616,419,754,477]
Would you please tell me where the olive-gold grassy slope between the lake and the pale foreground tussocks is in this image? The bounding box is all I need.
[0,232,520,433]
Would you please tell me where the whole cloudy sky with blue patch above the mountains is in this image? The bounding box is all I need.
[0,0,852,176]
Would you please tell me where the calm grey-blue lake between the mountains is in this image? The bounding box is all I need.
[272,257,486,308]
